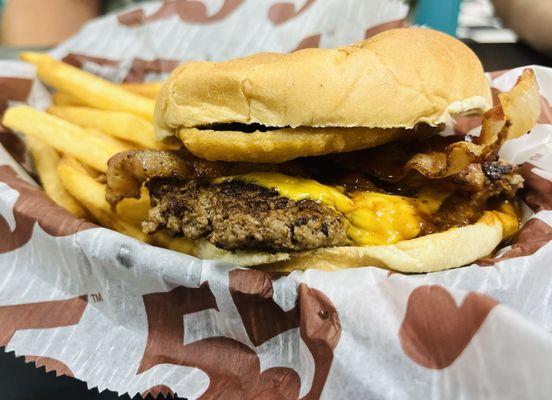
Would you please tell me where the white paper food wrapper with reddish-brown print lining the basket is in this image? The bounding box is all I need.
[0,0,552,399]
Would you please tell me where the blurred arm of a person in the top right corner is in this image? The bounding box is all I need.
[493,0,552,55]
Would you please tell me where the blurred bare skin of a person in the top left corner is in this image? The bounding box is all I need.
[2,0,101,46]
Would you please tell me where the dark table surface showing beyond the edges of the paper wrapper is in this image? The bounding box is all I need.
[0,42,552,400]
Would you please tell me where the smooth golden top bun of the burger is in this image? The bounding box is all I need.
[154,28,491,138]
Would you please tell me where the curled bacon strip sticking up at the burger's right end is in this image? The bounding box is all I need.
[334,69,540,188]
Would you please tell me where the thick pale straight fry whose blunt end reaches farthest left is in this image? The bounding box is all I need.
[2,106,132,172]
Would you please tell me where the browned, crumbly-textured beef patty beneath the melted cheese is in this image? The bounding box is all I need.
[143,179,350,251]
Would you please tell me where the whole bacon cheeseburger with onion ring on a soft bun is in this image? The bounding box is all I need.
[106,28,539,272]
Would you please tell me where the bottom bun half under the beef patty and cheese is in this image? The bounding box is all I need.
[179,212,504,273]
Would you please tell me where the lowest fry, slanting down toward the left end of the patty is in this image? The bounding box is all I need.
[58,155,150,243]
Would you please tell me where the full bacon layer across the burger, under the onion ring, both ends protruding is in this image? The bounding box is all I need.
[106,69,540,219]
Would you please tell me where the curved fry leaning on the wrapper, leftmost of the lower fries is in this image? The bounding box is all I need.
[27,136,88,218]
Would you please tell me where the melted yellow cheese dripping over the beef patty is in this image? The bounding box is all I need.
[215,172,448,246]
